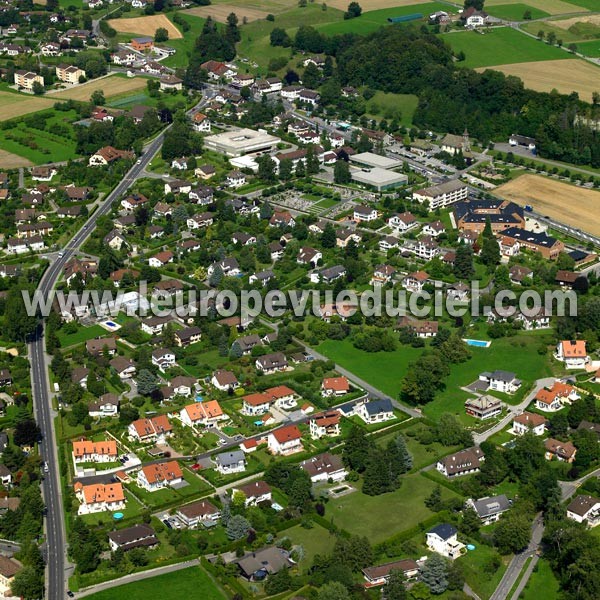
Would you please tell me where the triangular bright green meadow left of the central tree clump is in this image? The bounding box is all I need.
[317,339,423,398]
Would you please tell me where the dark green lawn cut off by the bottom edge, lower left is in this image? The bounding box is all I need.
[83,567,226,600]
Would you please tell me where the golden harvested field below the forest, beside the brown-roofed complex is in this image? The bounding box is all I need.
[494,175,600,235]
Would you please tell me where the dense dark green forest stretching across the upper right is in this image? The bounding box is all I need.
[330,26,600,167]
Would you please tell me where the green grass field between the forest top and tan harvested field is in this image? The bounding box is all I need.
[442,27,569,68]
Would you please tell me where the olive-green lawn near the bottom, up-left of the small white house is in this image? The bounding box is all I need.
[325,473,454,544]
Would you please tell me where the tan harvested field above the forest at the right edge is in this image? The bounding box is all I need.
[477,58,600,102]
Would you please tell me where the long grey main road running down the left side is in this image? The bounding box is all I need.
[29,133,163,600]
